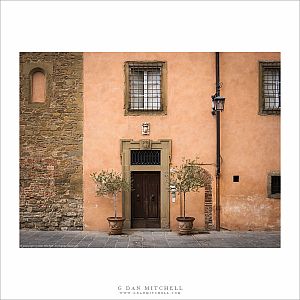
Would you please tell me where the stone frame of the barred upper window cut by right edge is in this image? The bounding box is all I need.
[258,60,281,116]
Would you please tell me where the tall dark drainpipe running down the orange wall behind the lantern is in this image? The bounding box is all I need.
[216,52,221,231]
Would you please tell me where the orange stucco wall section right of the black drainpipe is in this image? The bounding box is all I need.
[220,53,280,229]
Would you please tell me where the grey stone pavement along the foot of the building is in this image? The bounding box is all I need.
[20,230,280,248]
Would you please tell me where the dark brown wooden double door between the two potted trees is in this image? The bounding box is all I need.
[131,172,160,228]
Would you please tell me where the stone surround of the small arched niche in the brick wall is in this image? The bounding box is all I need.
[22,62,53,108]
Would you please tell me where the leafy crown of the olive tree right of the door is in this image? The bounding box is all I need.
[170,159,208,193]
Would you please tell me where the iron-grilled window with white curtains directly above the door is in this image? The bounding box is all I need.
[125,62,166,114]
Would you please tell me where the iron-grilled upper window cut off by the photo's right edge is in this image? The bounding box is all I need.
[259,61,281,114]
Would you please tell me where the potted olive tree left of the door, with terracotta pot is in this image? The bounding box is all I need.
[91,170,130,234]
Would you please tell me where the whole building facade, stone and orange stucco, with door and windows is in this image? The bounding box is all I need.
[20,52,281,231]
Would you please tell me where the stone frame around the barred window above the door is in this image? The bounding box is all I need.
[124,60,167,116]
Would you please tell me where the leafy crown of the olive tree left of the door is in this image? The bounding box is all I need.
[91,170,130,196]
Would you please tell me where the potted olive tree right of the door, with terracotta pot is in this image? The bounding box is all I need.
[170,159,207,234]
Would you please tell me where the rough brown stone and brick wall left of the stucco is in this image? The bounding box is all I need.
[20,52,83,230]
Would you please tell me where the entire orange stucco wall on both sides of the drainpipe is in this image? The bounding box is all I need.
[83,53,280,230]
